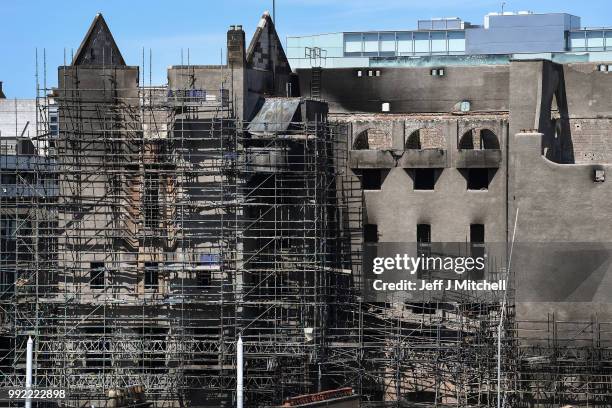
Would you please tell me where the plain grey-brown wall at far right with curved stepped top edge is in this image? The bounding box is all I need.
[511,133,612,321]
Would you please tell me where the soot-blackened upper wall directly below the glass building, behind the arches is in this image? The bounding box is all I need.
[297,66,510,113]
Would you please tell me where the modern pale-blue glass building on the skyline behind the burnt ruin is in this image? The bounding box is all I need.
[286,11,612,69]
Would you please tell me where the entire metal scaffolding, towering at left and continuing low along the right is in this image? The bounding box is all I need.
[0,52,612,407]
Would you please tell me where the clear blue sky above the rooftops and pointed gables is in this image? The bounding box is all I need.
[0,0,612,98]
